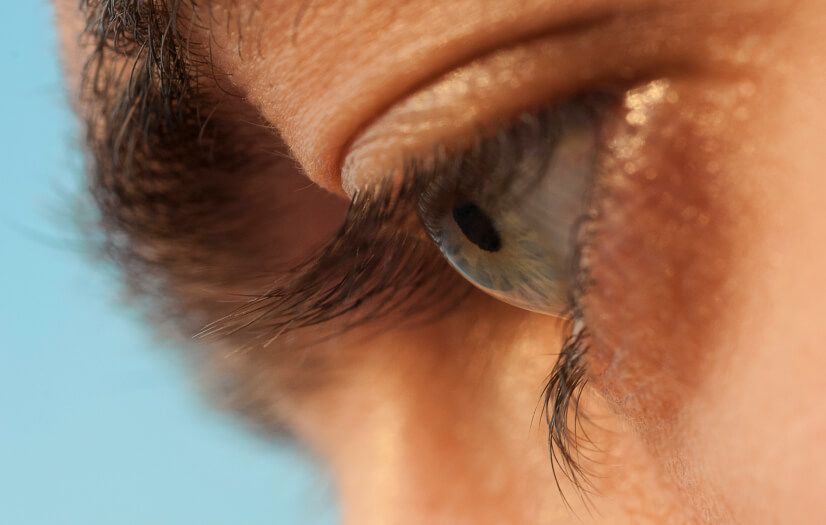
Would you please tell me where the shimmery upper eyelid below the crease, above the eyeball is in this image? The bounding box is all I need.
[334,7,682,195]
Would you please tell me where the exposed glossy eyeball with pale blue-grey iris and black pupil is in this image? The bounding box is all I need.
[416,104,598,315]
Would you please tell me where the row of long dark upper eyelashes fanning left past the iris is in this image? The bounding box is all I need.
[201,103,596,344]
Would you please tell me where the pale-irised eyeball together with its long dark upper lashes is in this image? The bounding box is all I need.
[207,91,616,338]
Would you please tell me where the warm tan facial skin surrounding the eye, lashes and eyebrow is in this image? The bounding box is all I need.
[57,0,826,525]
